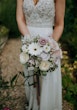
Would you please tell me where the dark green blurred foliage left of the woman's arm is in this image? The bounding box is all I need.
[0,0,19,37]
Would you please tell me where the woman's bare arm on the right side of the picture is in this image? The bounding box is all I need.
[52,0,65,41]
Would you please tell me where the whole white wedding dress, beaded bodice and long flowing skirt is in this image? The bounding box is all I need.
[21,0,62,110]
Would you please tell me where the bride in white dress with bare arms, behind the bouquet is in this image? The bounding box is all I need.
[16,0,65,110]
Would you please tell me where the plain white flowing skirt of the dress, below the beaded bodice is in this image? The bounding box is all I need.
[21,26,62,110]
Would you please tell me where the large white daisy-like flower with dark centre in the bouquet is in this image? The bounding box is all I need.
[28,43,42,56]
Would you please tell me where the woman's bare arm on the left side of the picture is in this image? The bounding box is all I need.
[16,0,30,36]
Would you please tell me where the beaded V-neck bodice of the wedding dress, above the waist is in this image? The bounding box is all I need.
[23,0,55,27]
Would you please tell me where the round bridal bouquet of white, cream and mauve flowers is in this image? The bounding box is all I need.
[20,35,62,75]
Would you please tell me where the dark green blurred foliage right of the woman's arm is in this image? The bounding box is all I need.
[61,0,77,59]
